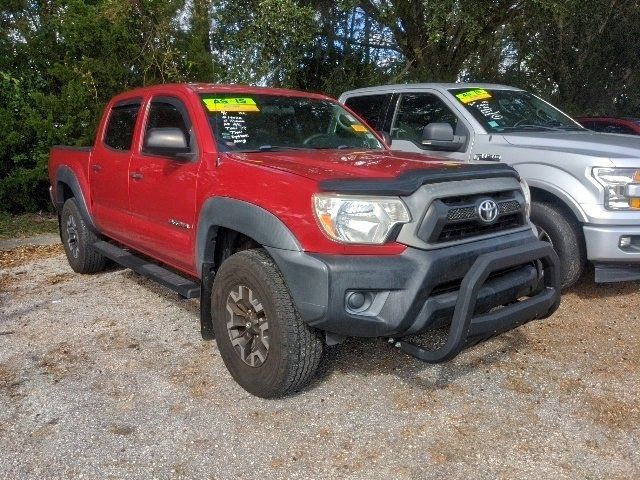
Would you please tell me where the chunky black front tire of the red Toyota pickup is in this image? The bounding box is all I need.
[211,249,324,398]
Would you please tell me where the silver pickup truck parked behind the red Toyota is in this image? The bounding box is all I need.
[340,83,640,287]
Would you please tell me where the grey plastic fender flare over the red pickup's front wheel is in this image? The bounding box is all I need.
[196,197,302,273]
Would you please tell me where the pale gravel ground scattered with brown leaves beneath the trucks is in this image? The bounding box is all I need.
[0,244,640,480]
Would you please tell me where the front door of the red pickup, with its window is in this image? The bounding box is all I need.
[129,96,199,271]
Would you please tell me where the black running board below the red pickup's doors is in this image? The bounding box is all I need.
[93,241,200,298]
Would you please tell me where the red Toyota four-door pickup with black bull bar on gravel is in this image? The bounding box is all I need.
[49,84,559,397]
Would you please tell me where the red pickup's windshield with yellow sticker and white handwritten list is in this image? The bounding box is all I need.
[201,93,383,152]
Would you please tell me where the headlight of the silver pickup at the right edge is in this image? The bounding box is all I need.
[593,167,640,210]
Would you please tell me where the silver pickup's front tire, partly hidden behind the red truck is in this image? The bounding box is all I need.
[531,201,587,289]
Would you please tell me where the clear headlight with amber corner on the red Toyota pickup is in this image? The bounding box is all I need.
[313,193,411,245]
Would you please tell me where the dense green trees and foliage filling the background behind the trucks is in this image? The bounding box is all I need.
[0,0,640,212]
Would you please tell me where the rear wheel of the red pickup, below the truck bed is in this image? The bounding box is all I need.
[60,198,106,273]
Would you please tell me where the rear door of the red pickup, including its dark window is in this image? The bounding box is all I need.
[89,99,142,239]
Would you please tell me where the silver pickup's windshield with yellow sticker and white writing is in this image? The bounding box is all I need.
[449,88,585,133]
